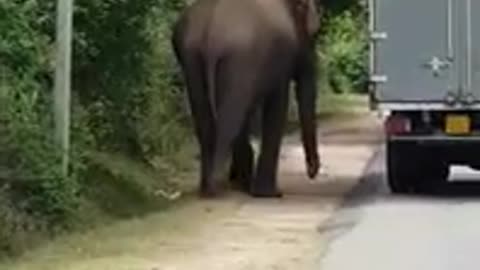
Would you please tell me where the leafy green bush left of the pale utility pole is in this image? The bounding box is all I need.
[0,1,82,220]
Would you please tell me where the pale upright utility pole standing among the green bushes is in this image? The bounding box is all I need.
[53,0,73,177]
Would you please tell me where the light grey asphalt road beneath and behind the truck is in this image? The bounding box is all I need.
[318,150,480,270]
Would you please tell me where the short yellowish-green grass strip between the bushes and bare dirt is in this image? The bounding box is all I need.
[0,199,235,270]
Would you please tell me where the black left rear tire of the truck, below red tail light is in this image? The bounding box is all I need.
[386,141,415,194]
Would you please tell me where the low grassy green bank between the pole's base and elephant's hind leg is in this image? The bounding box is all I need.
[70,144,199,226]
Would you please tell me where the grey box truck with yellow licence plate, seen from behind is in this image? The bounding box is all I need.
[368,0,480,193]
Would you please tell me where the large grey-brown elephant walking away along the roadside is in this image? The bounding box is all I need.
[171,0,320,198]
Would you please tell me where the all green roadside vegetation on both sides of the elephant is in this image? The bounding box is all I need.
[0,0,366,257]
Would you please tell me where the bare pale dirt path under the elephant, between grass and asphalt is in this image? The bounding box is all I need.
[146,116,380,270]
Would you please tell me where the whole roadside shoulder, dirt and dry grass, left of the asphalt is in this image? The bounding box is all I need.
[0,114,381,270]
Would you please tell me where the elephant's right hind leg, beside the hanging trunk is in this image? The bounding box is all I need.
[250,87,288,197]
